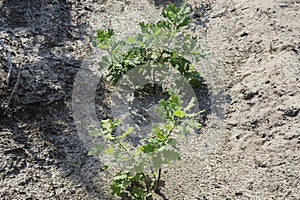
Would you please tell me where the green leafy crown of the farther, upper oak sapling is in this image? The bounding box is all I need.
[91,2,207,85]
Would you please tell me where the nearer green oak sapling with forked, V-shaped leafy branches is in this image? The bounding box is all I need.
[89,94,201,199]
